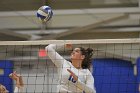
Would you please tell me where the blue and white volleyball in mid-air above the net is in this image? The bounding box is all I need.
[37,6,53,22]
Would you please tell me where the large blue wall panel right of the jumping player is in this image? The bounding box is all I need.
[92,59,138,93]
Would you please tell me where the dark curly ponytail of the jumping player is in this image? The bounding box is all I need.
[80,47,93,69]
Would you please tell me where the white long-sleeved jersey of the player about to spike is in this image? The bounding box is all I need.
[46,44,96,93]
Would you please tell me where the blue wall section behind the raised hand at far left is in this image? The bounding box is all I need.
[0,60,13,93]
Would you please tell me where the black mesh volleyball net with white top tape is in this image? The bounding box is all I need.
[0,39,140,93]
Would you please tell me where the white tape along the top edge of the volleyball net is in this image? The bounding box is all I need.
[0,38,140,45]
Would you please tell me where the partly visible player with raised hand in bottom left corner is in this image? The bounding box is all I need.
[0,72,23,93]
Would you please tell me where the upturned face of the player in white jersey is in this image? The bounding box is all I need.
[71,48,83,60]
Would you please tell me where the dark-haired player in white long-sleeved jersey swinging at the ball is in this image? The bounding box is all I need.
[45,44,96,93]
